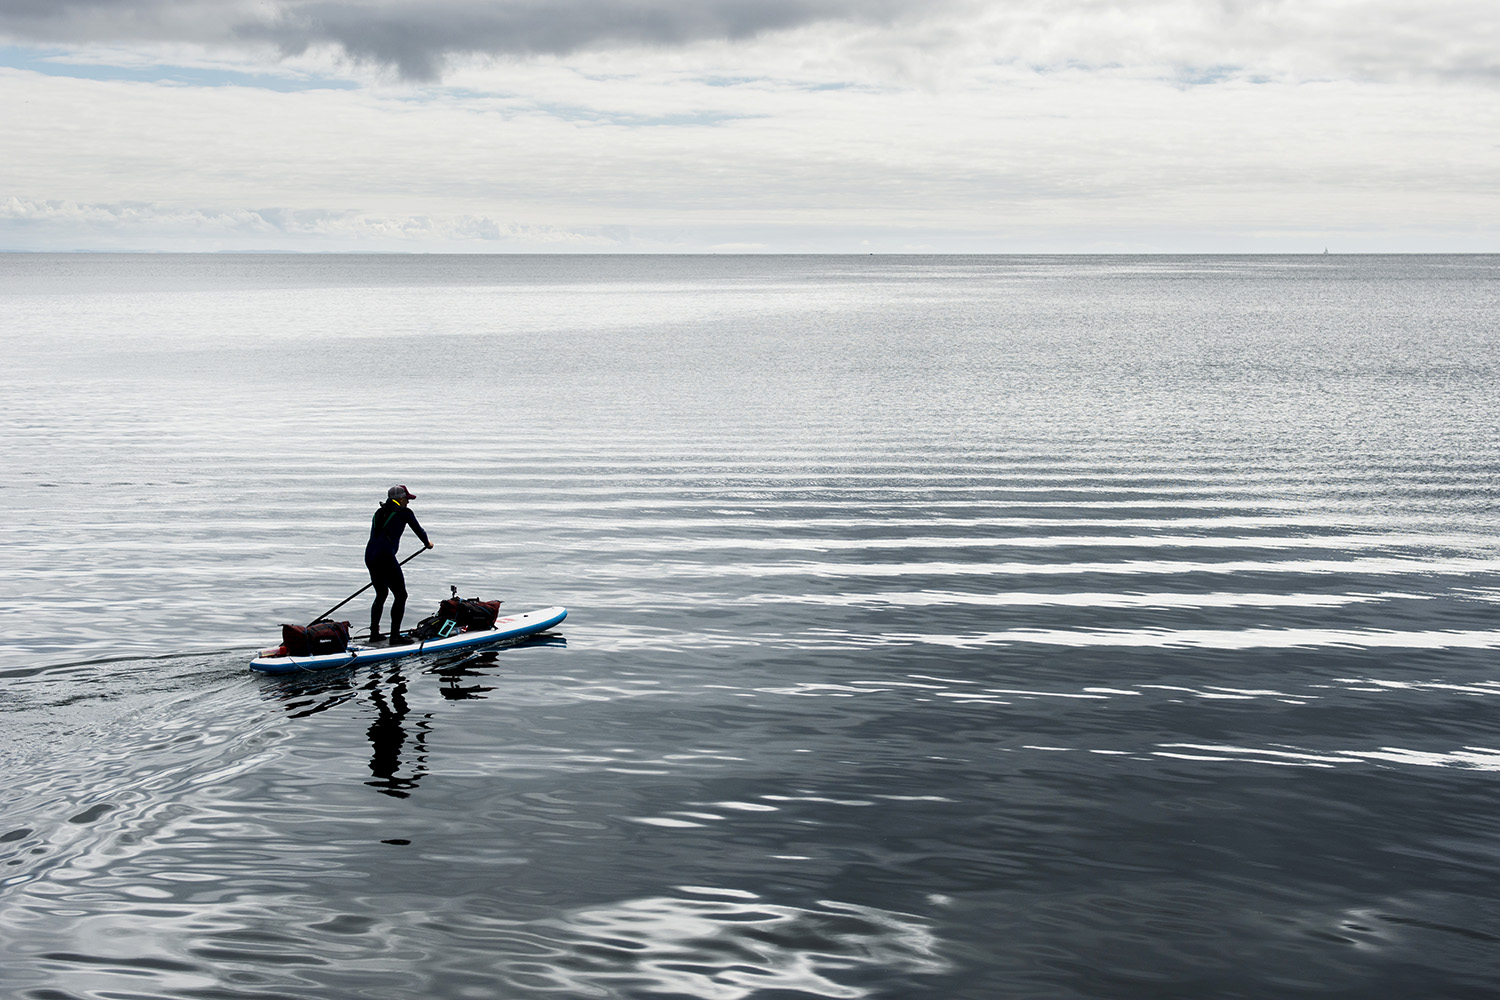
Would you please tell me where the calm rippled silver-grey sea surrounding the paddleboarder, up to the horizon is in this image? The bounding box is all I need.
[0,255,1500,1000]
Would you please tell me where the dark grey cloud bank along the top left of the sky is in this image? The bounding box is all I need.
[0,0,935,81]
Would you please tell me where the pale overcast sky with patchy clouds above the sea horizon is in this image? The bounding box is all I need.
[0,0,1500,253]
